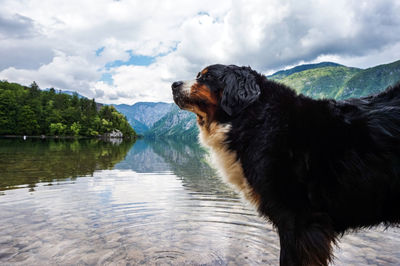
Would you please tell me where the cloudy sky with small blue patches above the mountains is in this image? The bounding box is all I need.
[0,0,400,105]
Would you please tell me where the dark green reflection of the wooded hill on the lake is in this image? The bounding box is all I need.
[0,139,133,190]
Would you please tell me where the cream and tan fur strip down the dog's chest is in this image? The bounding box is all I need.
[200,122,260,208]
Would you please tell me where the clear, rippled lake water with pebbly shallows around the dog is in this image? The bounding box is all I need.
[0,139,400,265]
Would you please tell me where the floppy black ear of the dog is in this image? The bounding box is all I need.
[221,67,260,116]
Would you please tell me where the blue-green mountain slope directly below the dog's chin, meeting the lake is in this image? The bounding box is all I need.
[145,104,198,139]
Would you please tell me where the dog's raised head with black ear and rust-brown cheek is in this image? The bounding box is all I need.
[172,65,260,124]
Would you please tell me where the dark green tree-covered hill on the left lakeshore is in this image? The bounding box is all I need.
[0,81,136,137]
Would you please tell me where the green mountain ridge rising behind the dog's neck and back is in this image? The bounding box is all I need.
[267,60,400,100]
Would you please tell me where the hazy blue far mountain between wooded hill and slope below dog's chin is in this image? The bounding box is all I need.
[114,102,173,135]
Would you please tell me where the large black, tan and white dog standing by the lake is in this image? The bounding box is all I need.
[172,64,400,265]
